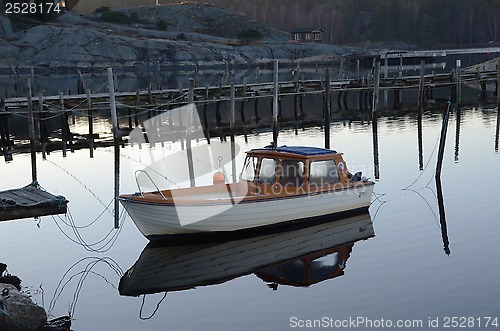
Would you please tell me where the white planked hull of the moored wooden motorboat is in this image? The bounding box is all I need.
[120,185,373,239]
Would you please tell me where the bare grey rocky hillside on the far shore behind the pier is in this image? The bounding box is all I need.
[0,4,368,69]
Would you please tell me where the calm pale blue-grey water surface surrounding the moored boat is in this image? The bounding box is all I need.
[0,109,500,331]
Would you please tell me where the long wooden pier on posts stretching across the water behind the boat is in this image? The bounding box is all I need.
[0,58,500,160]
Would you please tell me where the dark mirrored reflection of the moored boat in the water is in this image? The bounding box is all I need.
[119,213,375,296]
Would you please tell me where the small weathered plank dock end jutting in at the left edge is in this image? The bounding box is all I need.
[0,182,68,221]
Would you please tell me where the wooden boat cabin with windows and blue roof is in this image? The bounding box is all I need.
[241,146,361,195]
